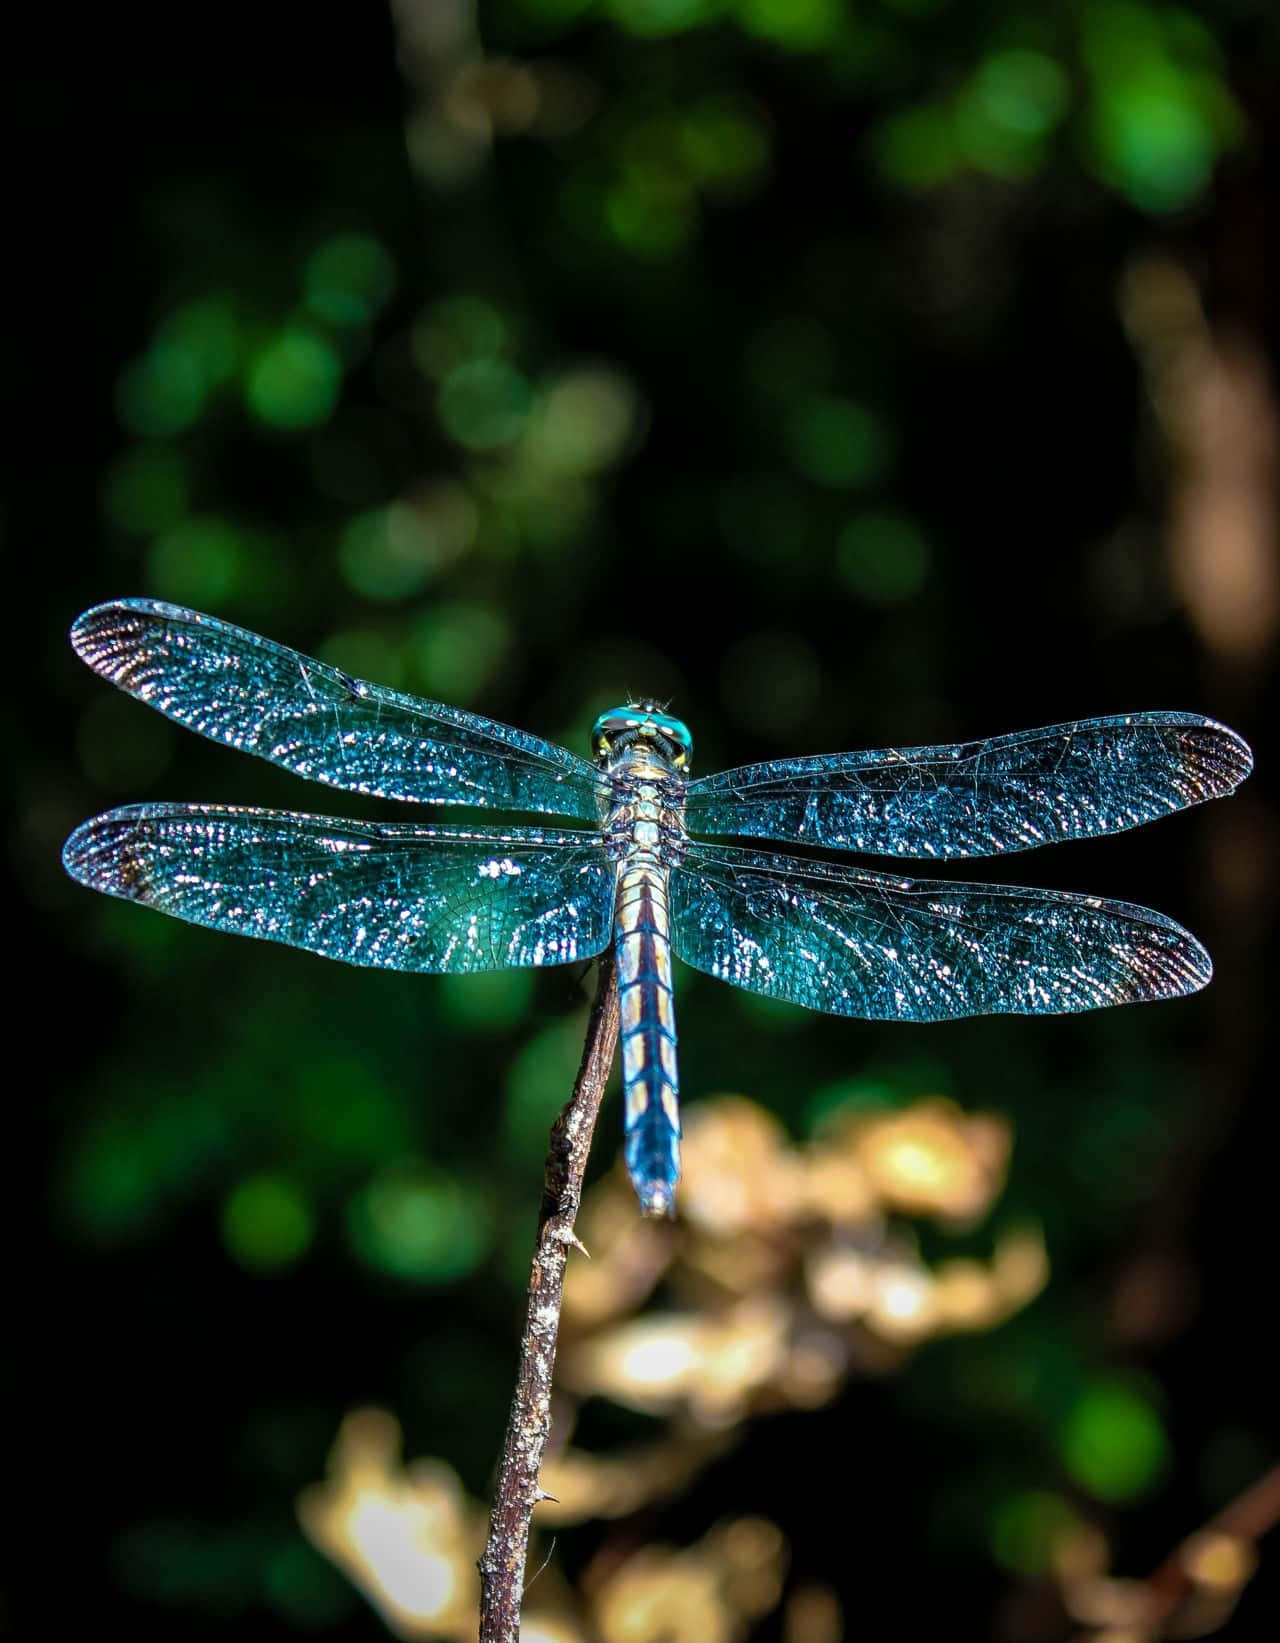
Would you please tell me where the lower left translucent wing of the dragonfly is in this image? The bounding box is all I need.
[62,805,615,974]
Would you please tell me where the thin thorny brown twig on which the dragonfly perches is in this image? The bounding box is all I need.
[480,950,618,1643]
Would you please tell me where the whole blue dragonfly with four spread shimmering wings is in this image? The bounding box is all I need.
[62,600,1252,1216]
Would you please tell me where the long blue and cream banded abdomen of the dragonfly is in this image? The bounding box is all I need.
[615,861,680,1216]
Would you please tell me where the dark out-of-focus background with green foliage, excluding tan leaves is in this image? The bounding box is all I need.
[7,0,1280,1638]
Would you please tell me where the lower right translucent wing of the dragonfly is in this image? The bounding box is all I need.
[670,845,1213,1022]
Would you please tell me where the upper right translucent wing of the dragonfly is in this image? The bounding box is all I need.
[685,713,1254,859]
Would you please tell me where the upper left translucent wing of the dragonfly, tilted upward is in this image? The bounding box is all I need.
[71,600,600,823]
